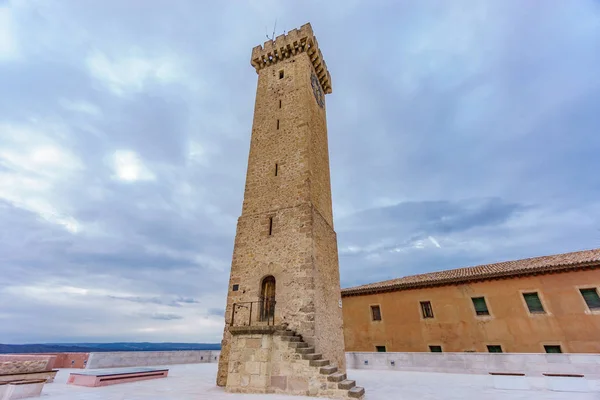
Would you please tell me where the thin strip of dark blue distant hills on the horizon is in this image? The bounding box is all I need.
[0,342,221,354]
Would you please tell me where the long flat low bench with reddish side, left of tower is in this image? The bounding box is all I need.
[67,368,169,387]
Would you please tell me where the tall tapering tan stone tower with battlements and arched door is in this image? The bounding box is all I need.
[217,24,362,397]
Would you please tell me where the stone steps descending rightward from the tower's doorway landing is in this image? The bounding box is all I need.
[277,329,365,399]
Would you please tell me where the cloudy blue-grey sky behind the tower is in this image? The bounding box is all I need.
[0,0,600,343]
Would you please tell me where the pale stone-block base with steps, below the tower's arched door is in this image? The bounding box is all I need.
[226,326,365,399]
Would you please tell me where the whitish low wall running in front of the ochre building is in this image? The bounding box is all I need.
[346,352,600,379]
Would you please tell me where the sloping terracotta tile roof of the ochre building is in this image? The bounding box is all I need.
[342,249,600,296]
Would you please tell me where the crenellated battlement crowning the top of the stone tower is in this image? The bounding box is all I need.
[250,23,331,94]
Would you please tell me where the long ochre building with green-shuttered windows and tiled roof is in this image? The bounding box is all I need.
[342,250,600,353]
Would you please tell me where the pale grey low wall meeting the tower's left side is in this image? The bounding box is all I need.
[86,350,221,369]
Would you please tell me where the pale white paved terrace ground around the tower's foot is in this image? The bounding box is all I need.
[41,364,600,400]
